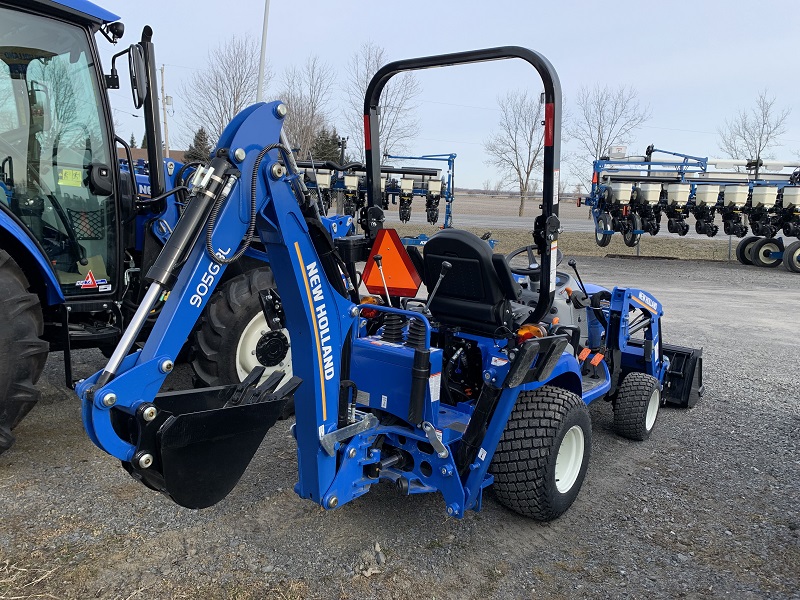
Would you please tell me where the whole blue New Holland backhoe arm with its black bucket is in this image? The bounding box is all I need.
[77,102,356,508]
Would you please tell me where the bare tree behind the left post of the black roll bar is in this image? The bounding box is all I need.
[344,42,420,160]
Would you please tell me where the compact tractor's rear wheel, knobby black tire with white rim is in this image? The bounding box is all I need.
[490,386,592,521]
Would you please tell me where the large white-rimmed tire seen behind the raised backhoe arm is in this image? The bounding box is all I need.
[191,267,294,418]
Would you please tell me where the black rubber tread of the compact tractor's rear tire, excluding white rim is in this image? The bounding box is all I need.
[489,386,591,521]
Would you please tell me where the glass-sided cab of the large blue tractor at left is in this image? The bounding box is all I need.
[0,6,119,298]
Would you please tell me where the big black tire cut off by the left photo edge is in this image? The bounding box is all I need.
[0,250,49,454]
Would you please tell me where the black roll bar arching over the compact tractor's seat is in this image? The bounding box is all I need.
[364,46,561,322]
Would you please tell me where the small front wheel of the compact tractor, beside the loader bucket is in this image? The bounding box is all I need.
[614,371,661,441]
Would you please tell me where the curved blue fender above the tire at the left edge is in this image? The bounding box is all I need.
[0,210,64,305]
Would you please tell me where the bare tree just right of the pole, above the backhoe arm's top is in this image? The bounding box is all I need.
[281,56,336,159]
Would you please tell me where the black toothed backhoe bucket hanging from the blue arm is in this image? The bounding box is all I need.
[123,369,301,508]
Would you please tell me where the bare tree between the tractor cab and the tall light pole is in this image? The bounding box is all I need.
[180,35,272,140]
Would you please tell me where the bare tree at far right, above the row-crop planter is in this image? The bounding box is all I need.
[717,90,792,161]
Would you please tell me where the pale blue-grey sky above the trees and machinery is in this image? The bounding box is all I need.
[97,0,800,187]
